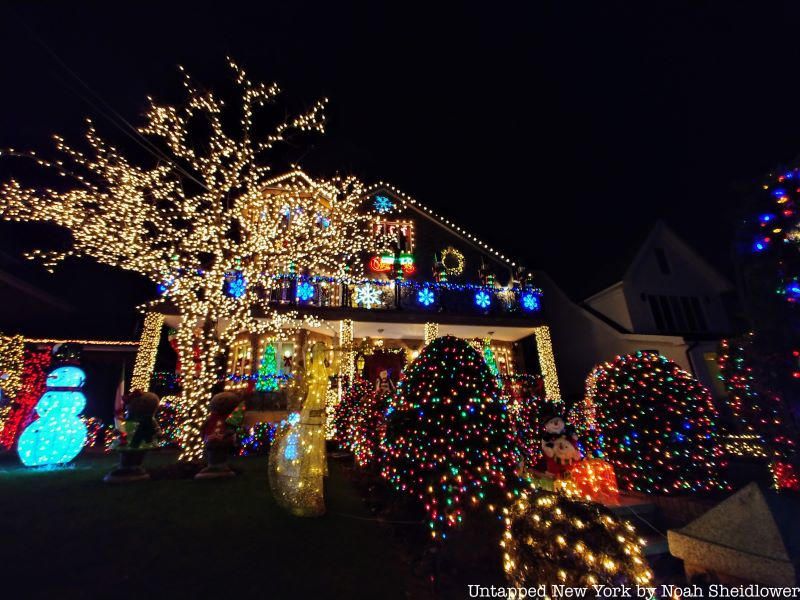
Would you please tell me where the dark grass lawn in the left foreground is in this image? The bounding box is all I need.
[0,454,411,600]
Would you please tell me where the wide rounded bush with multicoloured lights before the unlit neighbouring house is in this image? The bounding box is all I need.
[584,352,726,494]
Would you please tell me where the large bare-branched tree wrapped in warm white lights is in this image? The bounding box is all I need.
[0,62,390,460]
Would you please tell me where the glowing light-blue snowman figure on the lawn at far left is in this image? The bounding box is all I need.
[17,365,86,467]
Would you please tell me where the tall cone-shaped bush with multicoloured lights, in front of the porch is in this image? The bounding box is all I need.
[381,336,519,538]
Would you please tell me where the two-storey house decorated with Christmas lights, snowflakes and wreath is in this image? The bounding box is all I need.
[132,171,560,419]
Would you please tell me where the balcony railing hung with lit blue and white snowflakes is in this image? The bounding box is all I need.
[270,275,542,316]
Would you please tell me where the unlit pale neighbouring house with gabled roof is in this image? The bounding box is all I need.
[548,222,733,398]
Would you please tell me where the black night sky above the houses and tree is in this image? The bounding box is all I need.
[0,1,800,330]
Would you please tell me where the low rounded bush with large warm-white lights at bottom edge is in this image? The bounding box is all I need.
[500,491,653,593]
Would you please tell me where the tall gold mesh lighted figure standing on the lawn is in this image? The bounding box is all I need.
[269,342,330,517]
